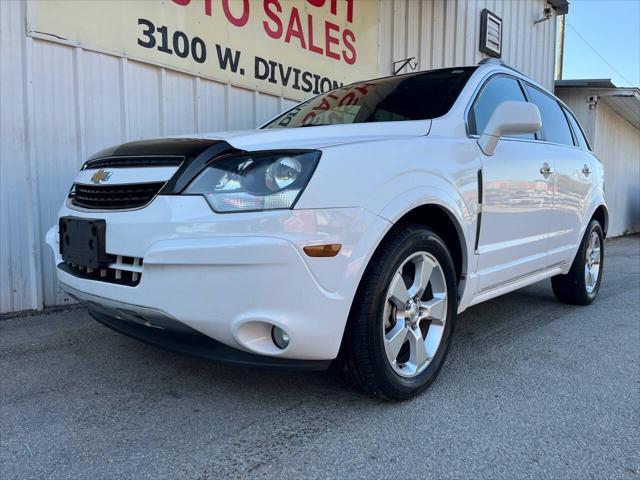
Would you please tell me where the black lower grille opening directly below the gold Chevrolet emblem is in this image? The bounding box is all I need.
[69,182,164,210]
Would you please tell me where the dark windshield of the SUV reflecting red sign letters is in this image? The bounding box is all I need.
[263,67,475,128]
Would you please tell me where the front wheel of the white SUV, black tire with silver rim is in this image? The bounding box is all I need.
[339,225,458,400]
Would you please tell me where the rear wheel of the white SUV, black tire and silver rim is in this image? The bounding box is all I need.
[551,220,604,305]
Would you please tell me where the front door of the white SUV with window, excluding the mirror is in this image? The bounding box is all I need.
[467,74,554,292]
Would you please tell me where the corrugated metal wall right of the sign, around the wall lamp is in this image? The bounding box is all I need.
[378,0,556,90]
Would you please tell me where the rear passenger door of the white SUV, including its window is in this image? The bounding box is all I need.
[525,83,591,265]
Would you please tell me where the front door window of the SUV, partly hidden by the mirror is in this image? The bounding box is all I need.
[468,75,535,139]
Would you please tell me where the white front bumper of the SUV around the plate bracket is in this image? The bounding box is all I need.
[47,195,390,360]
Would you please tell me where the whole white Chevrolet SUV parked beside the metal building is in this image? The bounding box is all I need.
[47,61,607,399]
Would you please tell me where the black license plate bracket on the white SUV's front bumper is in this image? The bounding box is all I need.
[58,217,109,269]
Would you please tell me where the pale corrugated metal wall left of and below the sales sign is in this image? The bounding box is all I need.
[0,1,296,313]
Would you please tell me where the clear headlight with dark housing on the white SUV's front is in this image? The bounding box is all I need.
[184,151,320,213]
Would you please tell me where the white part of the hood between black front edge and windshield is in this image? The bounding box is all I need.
[171,120,431,150]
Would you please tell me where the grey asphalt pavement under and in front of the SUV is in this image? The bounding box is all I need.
[0,236,640,480]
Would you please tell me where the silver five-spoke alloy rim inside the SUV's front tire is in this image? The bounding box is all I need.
[382,252,447,378]
